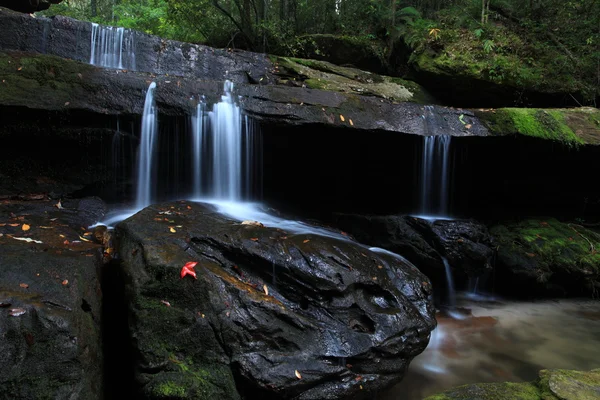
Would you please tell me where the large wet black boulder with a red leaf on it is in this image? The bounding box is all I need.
[117,202,435,399]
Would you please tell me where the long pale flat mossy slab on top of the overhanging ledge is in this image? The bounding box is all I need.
[271,56,436,104]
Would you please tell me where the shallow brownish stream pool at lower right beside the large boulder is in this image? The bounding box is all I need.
[378,293,600,400]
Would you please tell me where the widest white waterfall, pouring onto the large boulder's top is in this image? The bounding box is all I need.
[192,81,261,201]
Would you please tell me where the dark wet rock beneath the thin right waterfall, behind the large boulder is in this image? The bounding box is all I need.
[335,214,494,291]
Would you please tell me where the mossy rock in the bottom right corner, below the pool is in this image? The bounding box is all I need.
[425,369,600,400]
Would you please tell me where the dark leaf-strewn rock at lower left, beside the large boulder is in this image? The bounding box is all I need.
[0,199,104,400]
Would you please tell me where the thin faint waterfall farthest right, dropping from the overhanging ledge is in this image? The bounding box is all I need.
[421,135,450,216]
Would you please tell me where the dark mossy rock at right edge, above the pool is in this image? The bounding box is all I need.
[490,218,600,295]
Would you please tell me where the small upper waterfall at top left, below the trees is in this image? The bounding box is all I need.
[90,23,135,70]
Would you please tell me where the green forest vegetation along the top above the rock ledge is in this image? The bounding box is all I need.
[39,0,600,105]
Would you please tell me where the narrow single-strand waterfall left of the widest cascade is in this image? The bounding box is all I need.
[135,82,158,210]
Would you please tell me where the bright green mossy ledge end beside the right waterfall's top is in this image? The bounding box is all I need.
[475,107,600,146]
